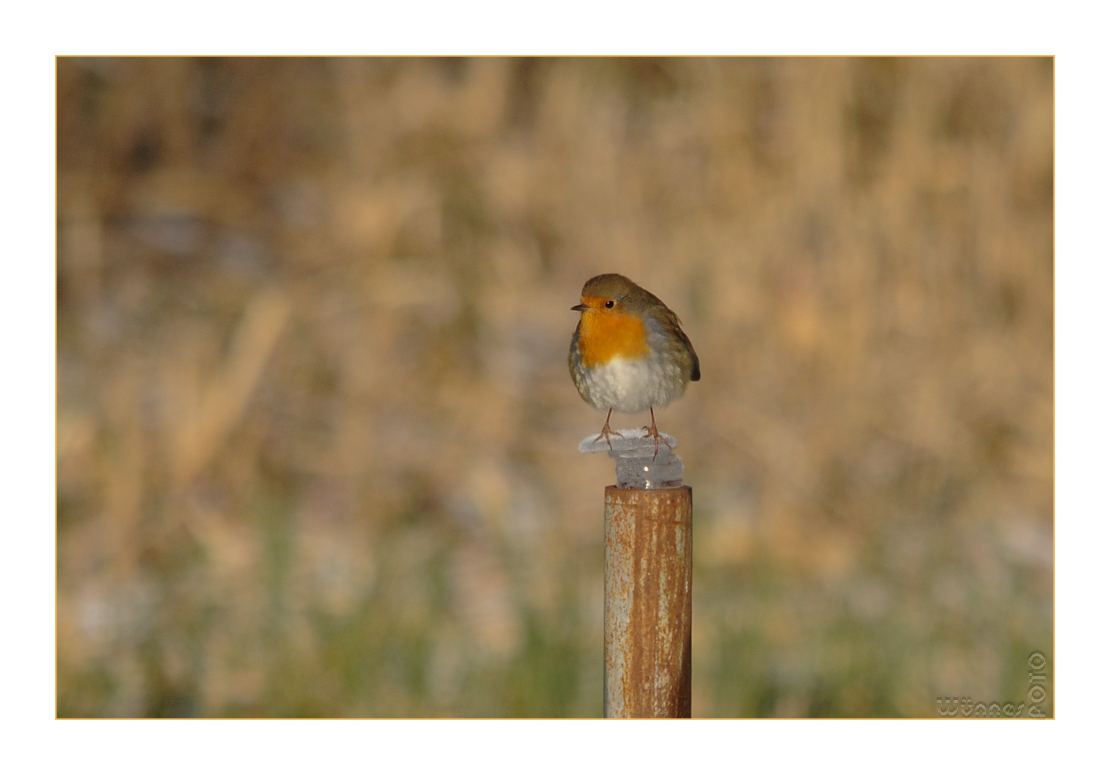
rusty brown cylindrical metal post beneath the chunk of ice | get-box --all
[605,485,694,718]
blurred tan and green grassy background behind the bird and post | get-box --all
[57,58,1053,717]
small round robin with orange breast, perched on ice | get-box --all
[568,274,702,454]
